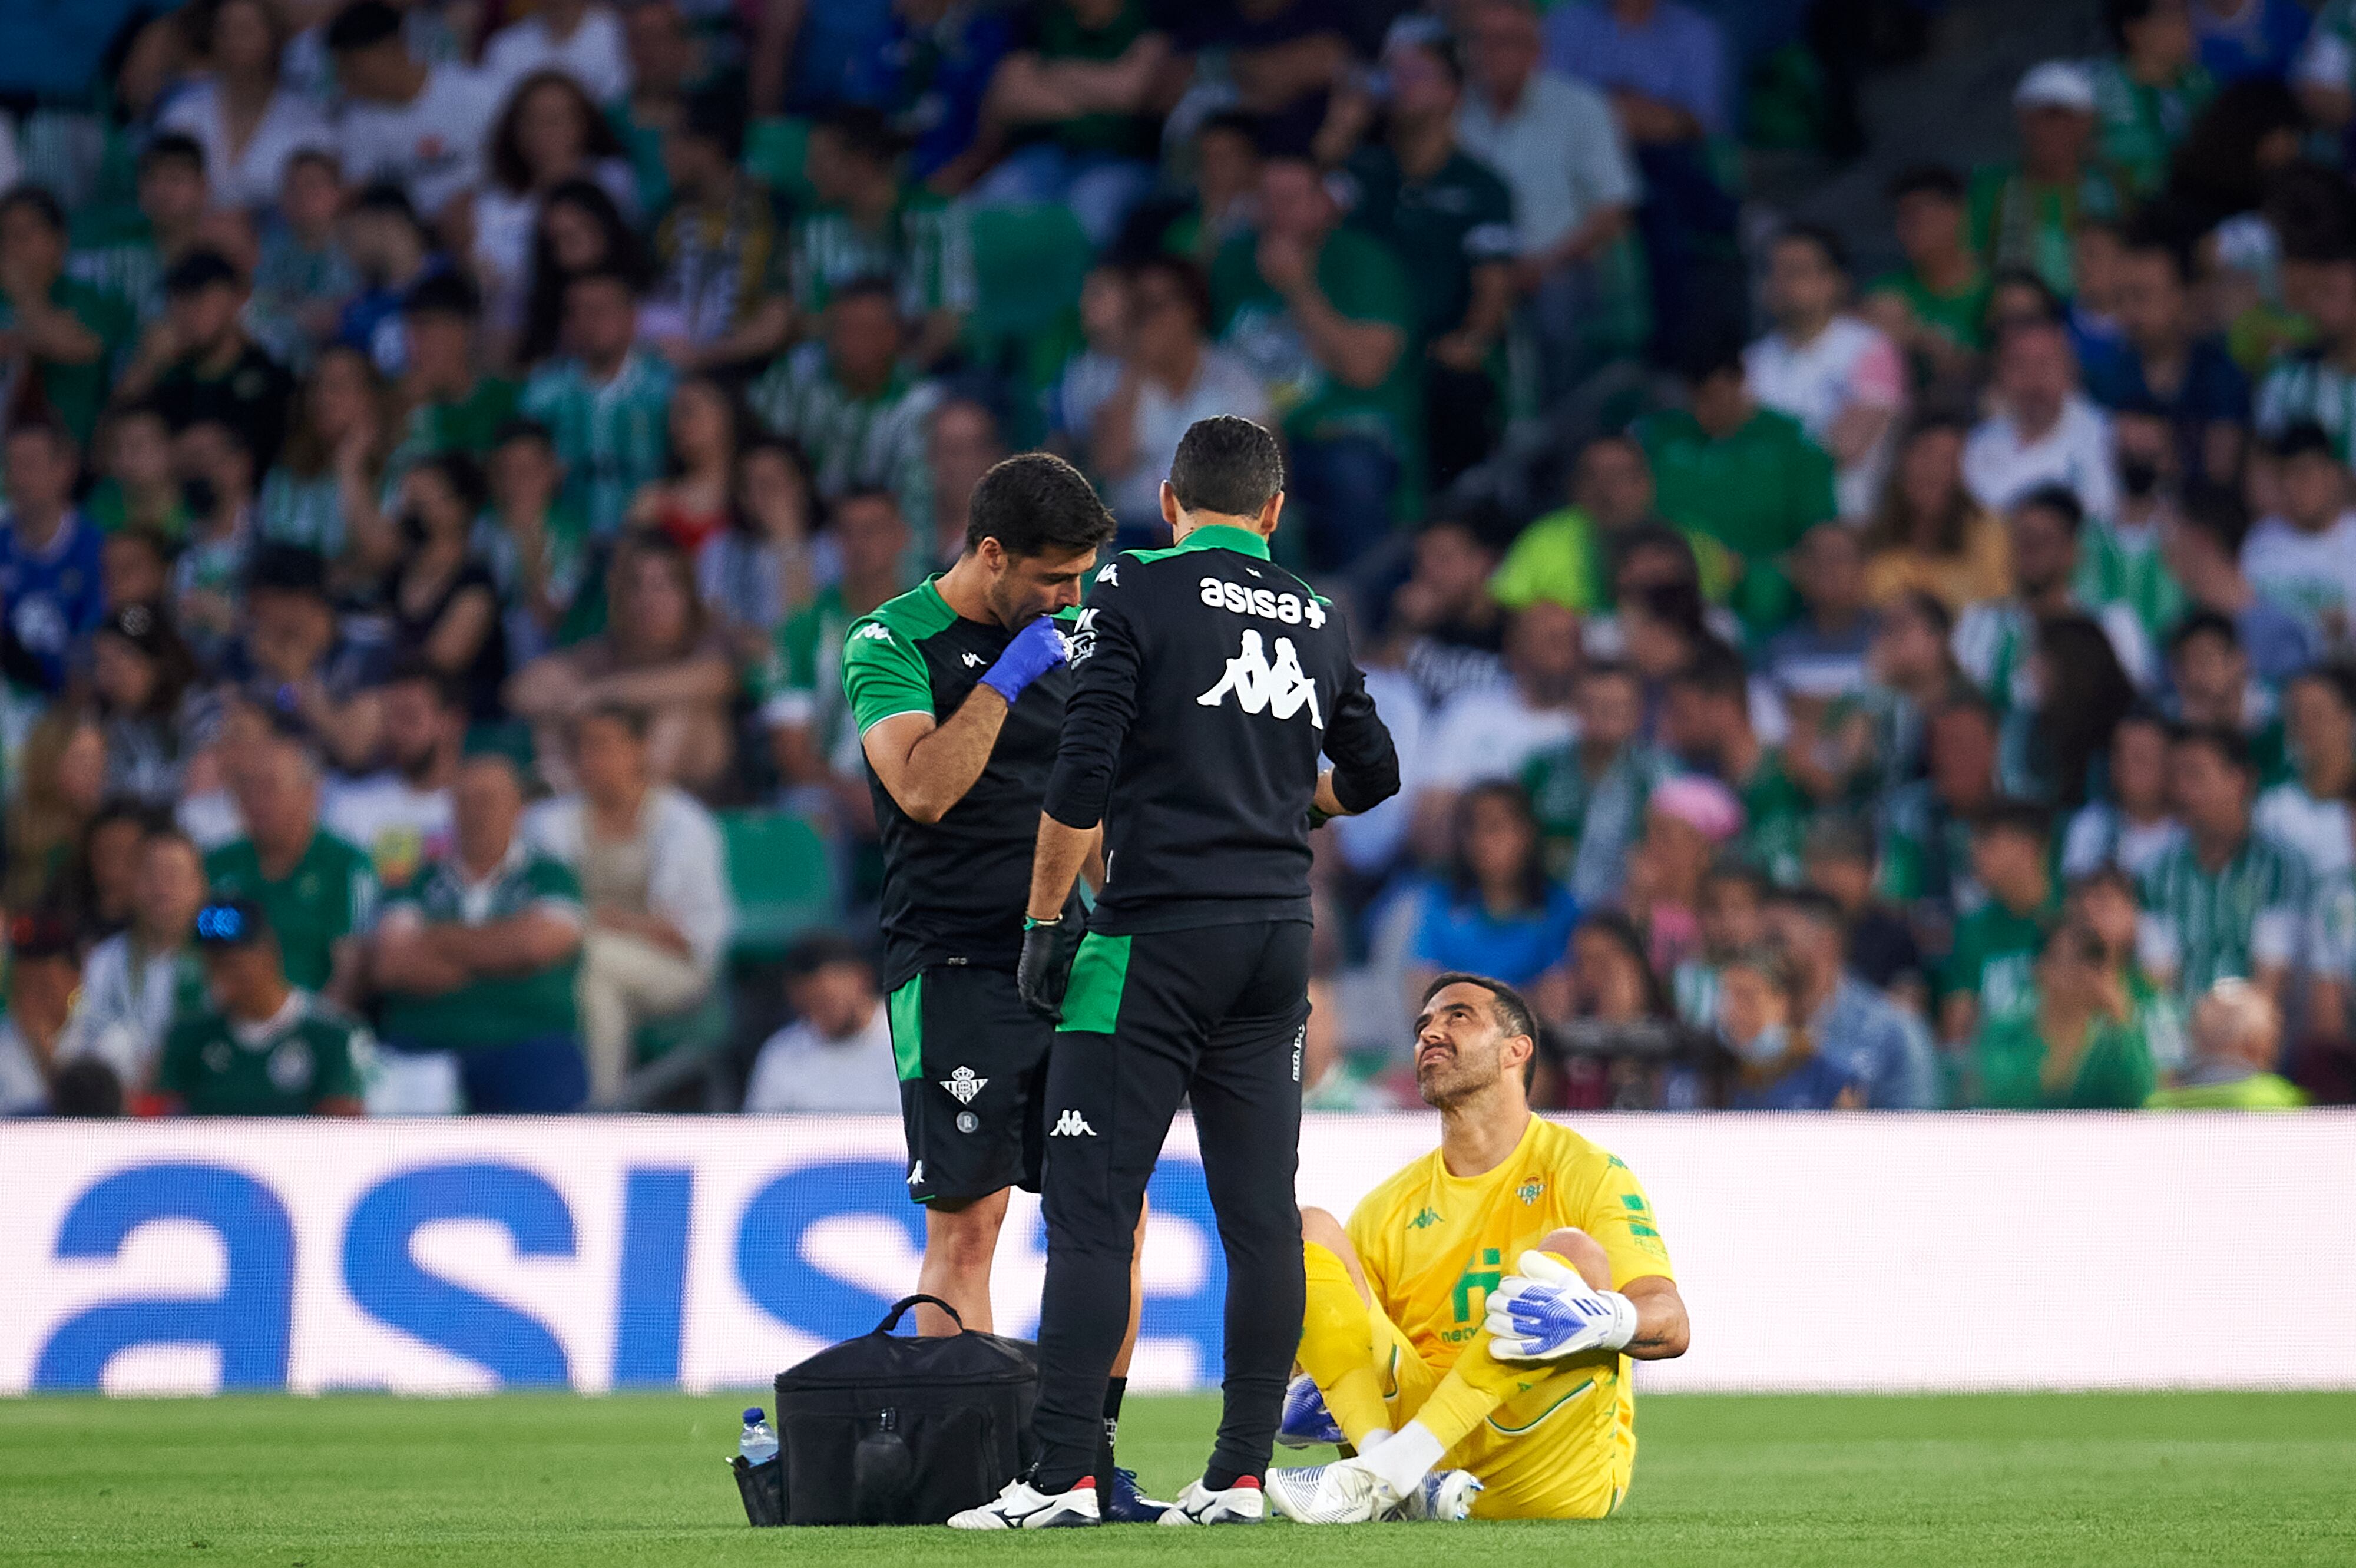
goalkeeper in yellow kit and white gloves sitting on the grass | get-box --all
[1268,975,1687,1523]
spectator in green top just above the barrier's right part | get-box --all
[1965,923,2158,1112]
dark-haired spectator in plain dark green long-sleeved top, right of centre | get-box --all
[1637,344,1840,633]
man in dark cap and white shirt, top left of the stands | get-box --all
[327,0,499,221]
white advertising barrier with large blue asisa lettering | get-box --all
[0,1112,2356,1394]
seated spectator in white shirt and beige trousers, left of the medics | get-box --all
[523,706,735,1104]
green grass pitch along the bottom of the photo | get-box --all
[0,1394,2356,1568]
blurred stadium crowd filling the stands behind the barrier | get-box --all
[0,0,2356,1114]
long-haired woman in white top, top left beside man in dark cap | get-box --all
[155,0,335,212]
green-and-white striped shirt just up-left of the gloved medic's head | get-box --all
[749,344,940,522]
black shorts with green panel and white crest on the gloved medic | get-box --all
[891,963,1055,1203]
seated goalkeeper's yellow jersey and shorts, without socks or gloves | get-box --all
[1350,1116,1675,1511]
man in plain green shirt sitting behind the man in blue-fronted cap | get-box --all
[205,737,377,1001]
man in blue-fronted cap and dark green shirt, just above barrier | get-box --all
[155,899,370,1116]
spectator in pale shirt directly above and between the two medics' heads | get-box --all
[1086,257,1275,532]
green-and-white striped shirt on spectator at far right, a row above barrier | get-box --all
[2137,831,2321,1001]
